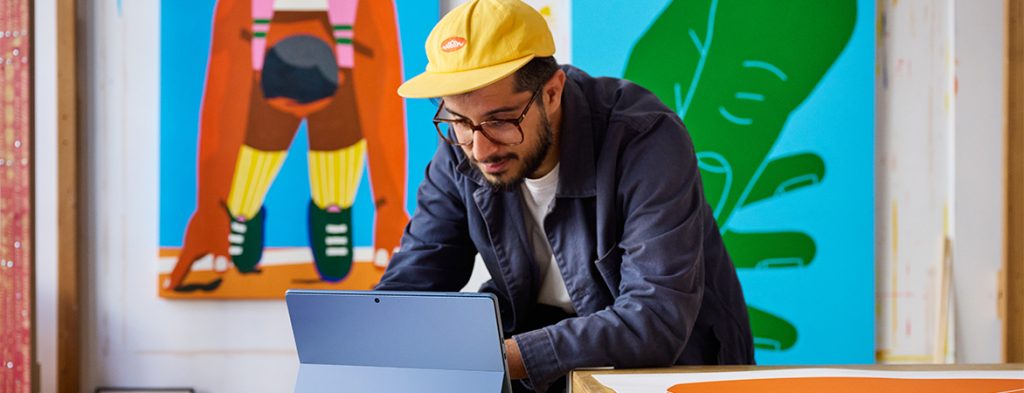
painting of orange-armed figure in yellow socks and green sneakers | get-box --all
[160,0,438,298]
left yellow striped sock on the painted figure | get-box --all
[227,144,288,218]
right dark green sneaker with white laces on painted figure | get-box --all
[309,201,352,282]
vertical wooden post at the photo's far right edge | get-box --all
[1004,0,1024,362]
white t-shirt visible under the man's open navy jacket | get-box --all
[521,165,575,313]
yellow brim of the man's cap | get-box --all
[398,54,535,98]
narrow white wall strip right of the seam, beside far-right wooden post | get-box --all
[952,0,1007,363]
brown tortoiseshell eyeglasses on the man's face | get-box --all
[434,85,544,146]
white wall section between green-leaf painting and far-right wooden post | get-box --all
[876,0,1006,362]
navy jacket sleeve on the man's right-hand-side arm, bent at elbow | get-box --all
[515,115,713,392]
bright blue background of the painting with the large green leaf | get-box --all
[572,0,876,364]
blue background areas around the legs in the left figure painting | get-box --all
[160,0,439,248]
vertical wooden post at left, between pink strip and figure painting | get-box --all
[56,0,82,393]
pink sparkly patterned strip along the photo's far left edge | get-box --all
[0,0,36,393]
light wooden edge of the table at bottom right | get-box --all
[569,363,1024,393]
